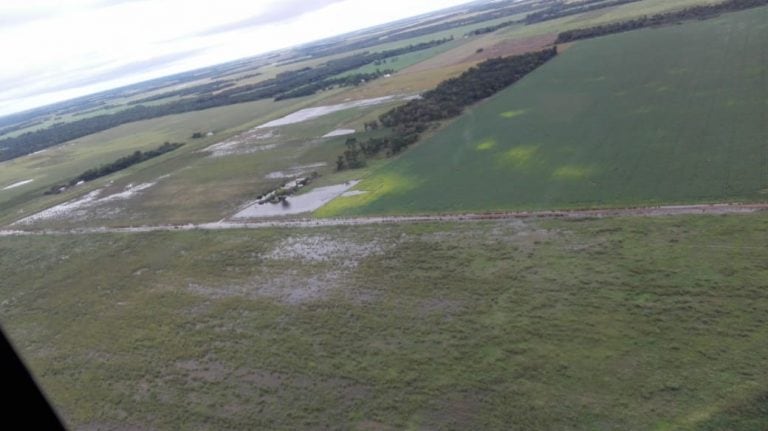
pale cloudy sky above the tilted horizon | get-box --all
[0,0,476,116]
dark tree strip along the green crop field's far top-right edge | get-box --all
[557,0,768,43]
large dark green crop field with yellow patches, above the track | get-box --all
[319,7,768,219]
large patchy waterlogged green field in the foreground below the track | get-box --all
[0,214,768,431]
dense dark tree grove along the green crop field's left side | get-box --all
[336,47,557,170]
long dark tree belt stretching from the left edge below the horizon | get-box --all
[0,38,451,161]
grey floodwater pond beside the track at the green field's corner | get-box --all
[232,181,359,219]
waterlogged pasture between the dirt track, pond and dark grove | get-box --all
[108,98,414,225]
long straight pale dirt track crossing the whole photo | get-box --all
[0,203,768,237]
